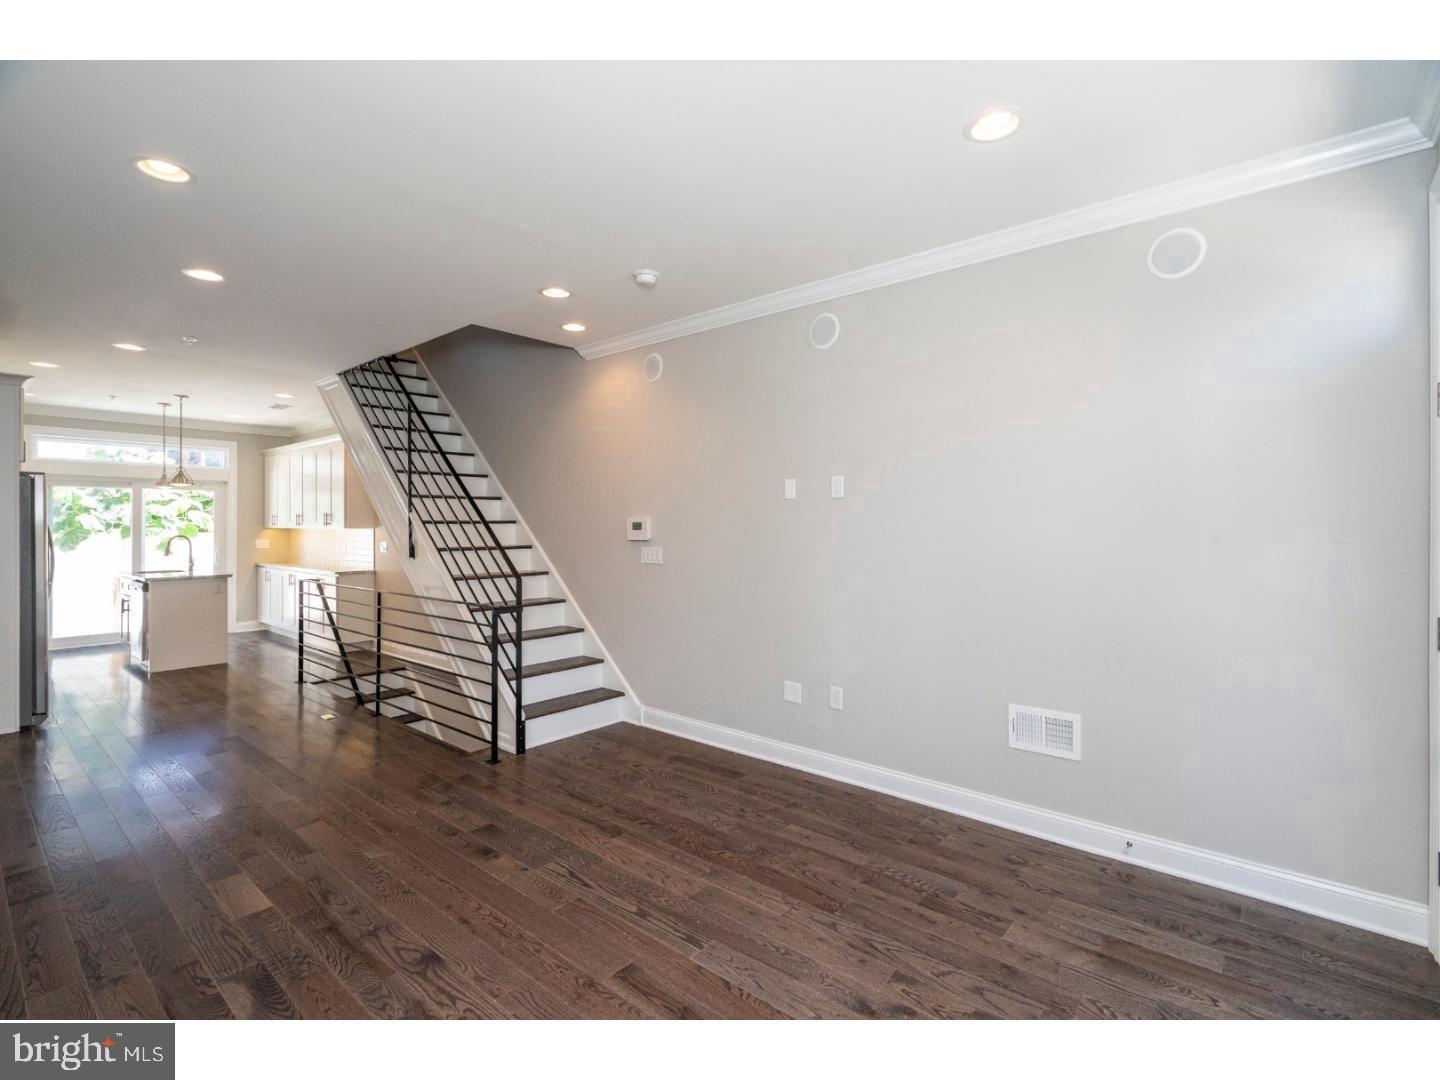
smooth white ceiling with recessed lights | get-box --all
[0,62,1426,428]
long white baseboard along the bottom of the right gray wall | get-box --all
[641,707,1430,945]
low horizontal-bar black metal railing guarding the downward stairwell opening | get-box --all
[297,577,501,762]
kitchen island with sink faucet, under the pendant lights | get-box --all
[120,570,230,674]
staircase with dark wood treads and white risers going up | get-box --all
[315,357,635,753]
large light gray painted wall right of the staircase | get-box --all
[420,153,1436,901]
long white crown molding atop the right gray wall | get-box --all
[576,120,1436,360]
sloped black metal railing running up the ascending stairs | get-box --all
[343,357,526,753]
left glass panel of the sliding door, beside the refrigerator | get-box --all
[49,481,134,647]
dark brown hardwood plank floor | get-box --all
[0,634,1440,1018]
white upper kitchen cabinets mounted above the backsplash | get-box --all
[265,435,377,528]
